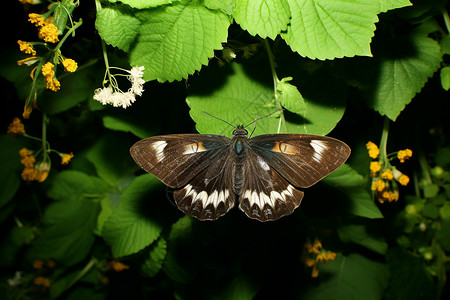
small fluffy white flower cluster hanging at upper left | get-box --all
[94,67,145,108]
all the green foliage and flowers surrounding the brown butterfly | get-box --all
[0,0,450,299]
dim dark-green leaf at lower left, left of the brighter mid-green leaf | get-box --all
[29,198,99,265]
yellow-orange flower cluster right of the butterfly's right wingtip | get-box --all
[366,142,412,203]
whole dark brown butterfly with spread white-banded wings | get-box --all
[130,118,350,222]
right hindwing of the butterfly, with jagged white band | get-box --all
[239,149,303,222]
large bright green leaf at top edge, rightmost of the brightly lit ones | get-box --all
[281,0,379,60]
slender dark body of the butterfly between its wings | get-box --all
[231,125,248,194]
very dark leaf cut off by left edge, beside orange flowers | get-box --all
[0,135,23,209]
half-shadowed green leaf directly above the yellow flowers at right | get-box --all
[355,30,442,121]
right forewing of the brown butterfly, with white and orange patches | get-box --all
[249,134,350,188]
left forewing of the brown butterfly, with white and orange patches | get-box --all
[130,134,230,188]
